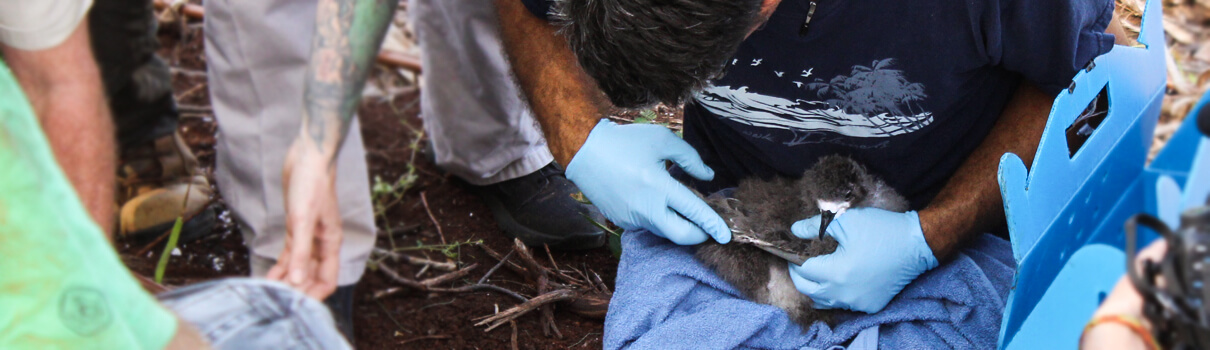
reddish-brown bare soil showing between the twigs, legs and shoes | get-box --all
[117,12,617,349]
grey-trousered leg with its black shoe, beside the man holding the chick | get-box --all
[408,0,606,249]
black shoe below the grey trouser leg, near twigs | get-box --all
[476,162,606,251]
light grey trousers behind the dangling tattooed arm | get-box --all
[204,0,376,286]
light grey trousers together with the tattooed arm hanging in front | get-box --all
[204,0,384,340]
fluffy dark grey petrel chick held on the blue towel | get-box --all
[696,155,908,329]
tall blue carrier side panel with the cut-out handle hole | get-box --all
[998,0,1166,348]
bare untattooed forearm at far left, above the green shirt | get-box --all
[0,22,117,235]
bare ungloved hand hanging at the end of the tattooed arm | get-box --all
[266,137,342,300]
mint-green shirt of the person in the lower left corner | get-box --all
[0,61,177,349]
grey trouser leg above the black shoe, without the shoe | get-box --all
[408,0,554,185]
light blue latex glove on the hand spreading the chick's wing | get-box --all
[565,120,731,245]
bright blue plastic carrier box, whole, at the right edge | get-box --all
[998,0,1210,349]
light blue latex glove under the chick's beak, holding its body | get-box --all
[790,208,937,314]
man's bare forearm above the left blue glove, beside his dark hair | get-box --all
[495,0,609,165]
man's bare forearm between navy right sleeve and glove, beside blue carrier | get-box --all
[920,82,1054,260]
